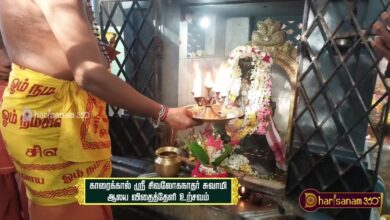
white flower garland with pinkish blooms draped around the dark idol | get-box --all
[227,45,272,140]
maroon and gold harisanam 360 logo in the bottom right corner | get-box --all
[299,189,383,212]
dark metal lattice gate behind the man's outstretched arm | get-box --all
[99,0,162,158]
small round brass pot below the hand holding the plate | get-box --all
[154,146,180,177]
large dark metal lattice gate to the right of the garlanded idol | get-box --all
[286,0,390,219]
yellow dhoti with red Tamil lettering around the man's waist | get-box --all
[0,65,111,206]
